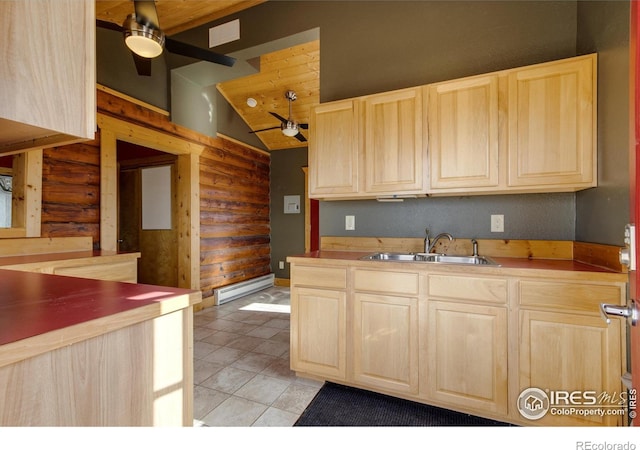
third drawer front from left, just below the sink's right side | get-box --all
[428,275,508,303]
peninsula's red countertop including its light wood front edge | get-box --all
[0,269,202,367]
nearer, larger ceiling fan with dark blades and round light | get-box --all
[96,0,236,76]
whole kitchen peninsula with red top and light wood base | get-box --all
[0,270,201,426]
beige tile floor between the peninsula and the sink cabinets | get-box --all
[189,286,322,427]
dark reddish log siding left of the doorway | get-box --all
[41,140,100,249]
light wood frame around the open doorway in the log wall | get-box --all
[97,113,204,290]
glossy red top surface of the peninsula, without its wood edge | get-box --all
[0,269,201,345]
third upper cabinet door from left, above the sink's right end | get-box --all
[427,75,499,191]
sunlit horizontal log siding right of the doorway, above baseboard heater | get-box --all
[200,139,271,298]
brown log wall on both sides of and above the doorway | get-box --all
[37,89,271,304]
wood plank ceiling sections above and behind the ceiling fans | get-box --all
[96,0,320,150]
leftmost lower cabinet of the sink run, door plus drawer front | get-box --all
[290,266,347,380]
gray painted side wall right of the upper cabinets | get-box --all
[576,1,629,245]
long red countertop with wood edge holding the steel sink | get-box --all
[287,250,628,282]
